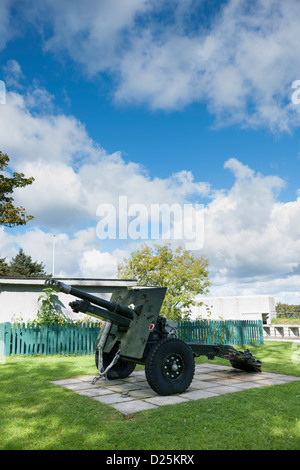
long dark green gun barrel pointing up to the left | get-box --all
[45,278,136,320]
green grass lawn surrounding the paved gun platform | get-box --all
[0,342,300,450]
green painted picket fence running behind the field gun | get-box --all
[0,320,263,356]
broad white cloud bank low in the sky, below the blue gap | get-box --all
[0,80,300,298]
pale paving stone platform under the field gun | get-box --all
[51,364,300,415]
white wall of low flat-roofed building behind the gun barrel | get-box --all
[0,277,136,323]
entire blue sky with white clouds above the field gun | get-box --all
[0,0,300,303]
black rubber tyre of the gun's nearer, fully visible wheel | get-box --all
[145,337,195,396]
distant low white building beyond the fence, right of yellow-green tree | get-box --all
[192,295,276,324]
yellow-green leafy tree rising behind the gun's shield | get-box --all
[117,244,210,321]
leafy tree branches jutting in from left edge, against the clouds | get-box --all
[0,152,34,227]
